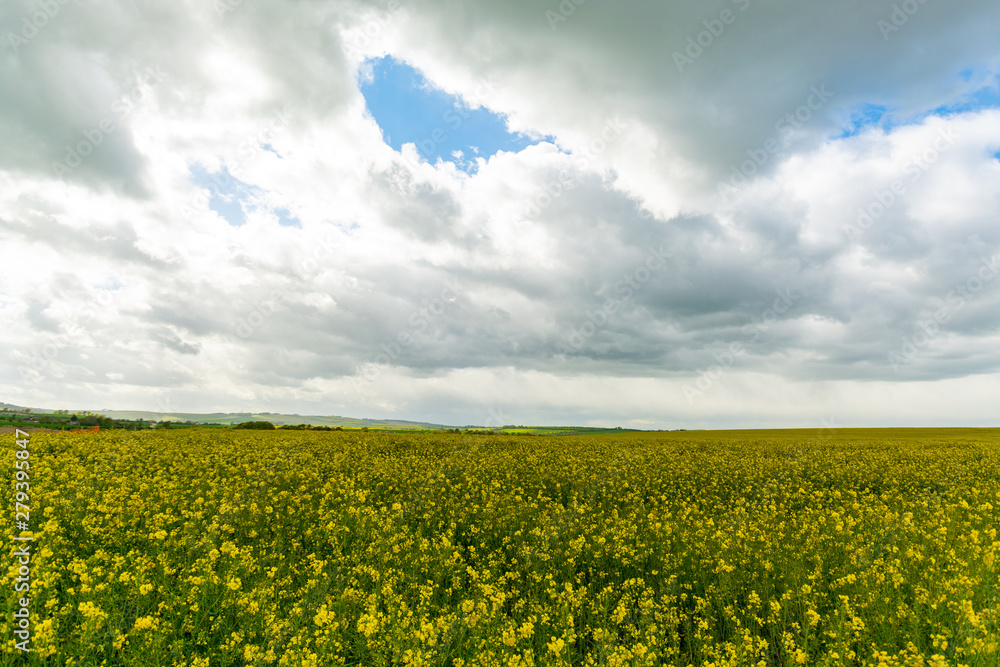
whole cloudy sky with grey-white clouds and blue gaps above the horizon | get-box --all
[0,0,1000,429]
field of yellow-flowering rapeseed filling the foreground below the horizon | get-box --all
[0,428,1000,667]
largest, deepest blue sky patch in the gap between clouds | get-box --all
[359,56,541,173]
